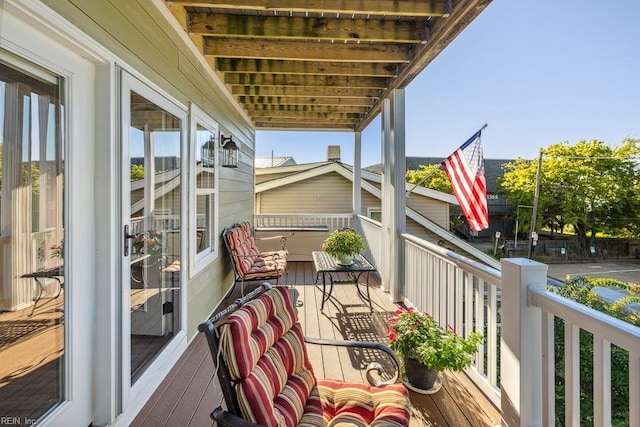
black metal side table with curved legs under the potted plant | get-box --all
[311,251,376,311]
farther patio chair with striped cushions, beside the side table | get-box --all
[222,222,289,295]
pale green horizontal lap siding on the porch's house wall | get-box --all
[43,0,255,336]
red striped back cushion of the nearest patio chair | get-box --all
[218,288,315,427]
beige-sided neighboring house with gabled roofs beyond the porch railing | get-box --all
[255,150,499,267]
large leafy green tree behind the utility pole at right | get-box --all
[499,139,640,250]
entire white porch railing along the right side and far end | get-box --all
[256,214,640,426]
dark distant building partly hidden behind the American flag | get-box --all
[364,157,517,238]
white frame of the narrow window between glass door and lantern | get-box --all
[189,103,220,278]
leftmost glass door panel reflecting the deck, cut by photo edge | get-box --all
[0,52,68,425]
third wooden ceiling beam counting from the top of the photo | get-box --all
[204,37,410,63]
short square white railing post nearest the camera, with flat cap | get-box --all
[500,258,547,427]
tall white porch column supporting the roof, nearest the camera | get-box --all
[381,89,407,300]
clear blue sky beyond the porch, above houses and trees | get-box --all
[256,0,640,166]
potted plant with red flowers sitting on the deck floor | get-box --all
[389,308,483,390]
